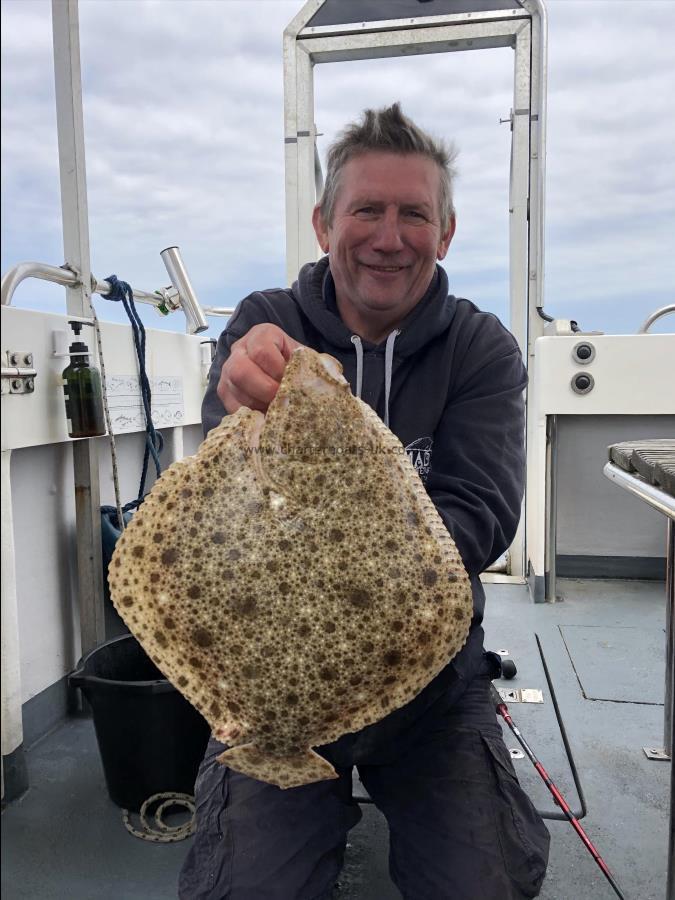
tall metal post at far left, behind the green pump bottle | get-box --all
[52,0,105,653]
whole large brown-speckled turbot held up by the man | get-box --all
[109,348,472,788]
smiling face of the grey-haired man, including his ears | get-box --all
[313,152,455,339]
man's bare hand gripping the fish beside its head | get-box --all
[217,323,302,413]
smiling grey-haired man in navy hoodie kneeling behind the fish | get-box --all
[180,104,549,900]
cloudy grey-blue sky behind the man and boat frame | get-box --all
[2,0,675,334]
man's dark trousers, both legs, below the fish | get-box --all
[179,659,549,900]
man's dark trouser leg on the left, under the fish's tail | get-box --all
[179,742,361,900]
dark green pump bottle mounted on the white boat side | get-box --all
[62,322,105,438]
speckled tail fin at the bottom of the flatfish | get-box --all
[218,743,338,788]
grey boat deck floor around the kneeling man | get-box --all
[2,580,670,900]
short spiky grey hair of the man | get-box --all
[320,103,457,231]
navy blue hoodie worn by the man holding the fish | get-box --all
[202,256,527,744]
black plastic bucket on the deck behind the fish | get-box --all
[69,634,210,812]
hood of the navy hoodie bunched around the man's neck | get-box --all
[292,256,457,357]
